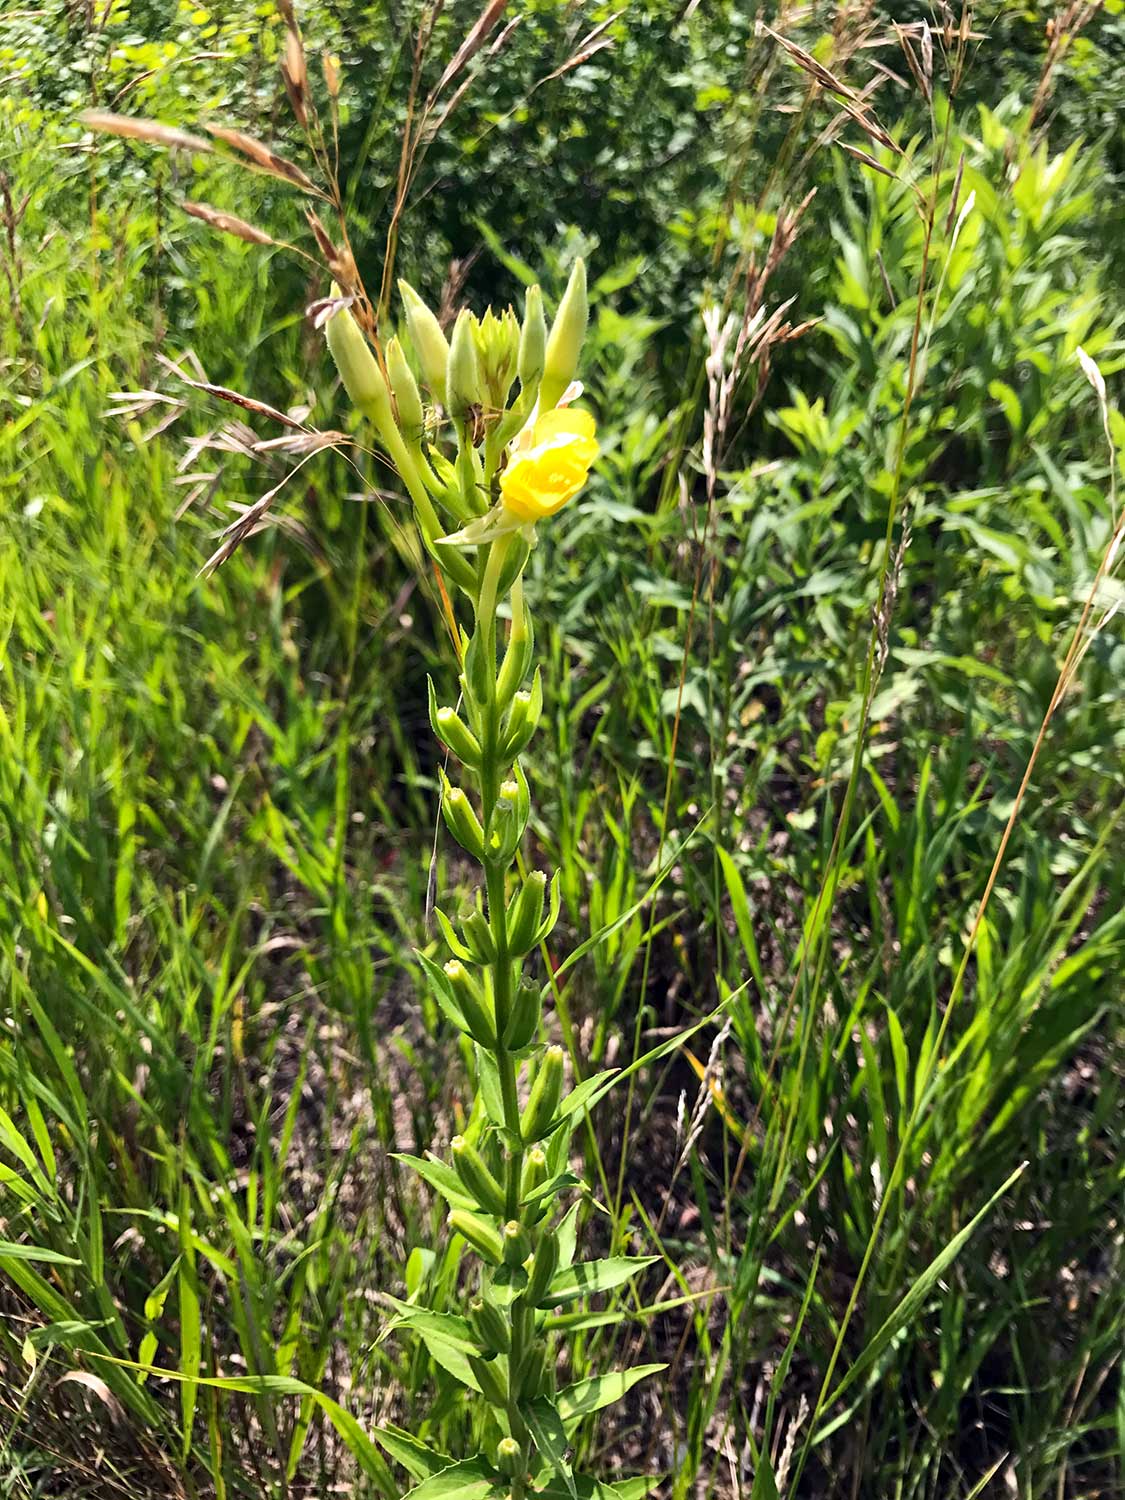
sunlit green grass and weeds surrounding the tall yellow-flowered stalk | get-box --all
[0,8,1125,1500]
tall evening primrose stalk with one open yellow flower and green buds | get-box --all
[326,261,662,1500]
